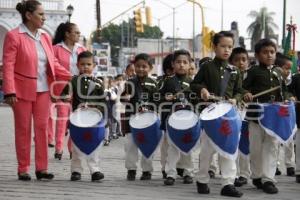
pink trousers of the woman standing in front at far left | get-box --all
[13,92,50,173]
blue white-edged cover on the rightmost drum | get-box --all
[259,102,297,144]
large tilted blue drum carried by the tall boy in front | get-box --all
[200,102,242,160]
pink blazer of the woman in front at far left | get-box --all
[3,27,71,101]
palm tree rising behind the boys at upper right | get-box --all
[247,7,278,50]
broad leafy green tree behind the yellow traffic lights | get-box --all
[91,19,163,66]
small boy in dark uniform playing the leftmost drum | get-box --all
[62,51,105,181]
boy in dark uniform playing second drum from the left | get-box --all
[121,53,157,181]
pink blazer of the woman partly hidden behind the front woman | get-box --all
[53,44,86,96]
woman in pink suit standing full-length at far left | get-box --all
[3,0,70,181]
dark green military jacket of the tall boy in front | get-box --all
[191,58,246,101]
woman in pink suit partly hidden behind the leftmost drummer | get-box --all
[48,22,86,160]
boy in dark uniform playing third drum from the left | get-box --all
[159,50,196,185]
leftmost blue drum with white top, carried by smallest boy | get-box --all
[70,108,105,155]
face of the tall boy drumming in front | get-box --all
[214,37,233,60]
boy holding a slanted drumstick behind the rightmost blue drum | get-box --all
[243,39,288,194]
